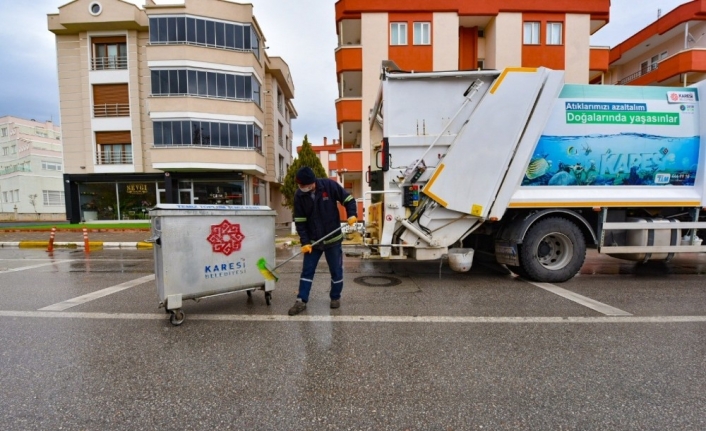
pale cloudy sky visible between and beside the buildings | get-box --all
[0,0,689,145]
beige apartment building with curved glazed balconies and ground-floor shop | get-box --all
[48,0,297,224]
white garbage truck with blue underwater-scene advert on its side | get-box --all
[365,66,706,282]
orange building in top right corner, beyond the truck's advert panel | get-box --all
[603,0,706,87]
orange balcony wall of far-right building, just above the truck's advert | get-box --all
[617,49,706,85]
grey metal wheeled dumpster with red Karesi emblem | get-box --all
[148,204,276,325]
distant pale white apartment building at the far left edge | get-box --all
[0,116,66,221]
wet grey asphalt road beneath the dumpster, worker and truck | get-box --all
[0,249,706,430]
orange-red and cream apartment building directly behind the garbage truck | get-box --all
[335,0,610,207]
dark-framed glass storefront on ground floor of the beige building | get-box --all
[64,172,267,223]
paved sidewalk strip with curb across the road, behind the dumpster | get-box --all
[0,228,299,249]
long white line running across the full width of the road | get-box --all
[0,311,706,324]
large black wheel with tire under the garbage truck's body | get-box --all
[518,217,586,283]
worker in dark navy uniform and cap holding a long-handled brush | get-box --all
[289,166,358,316]
